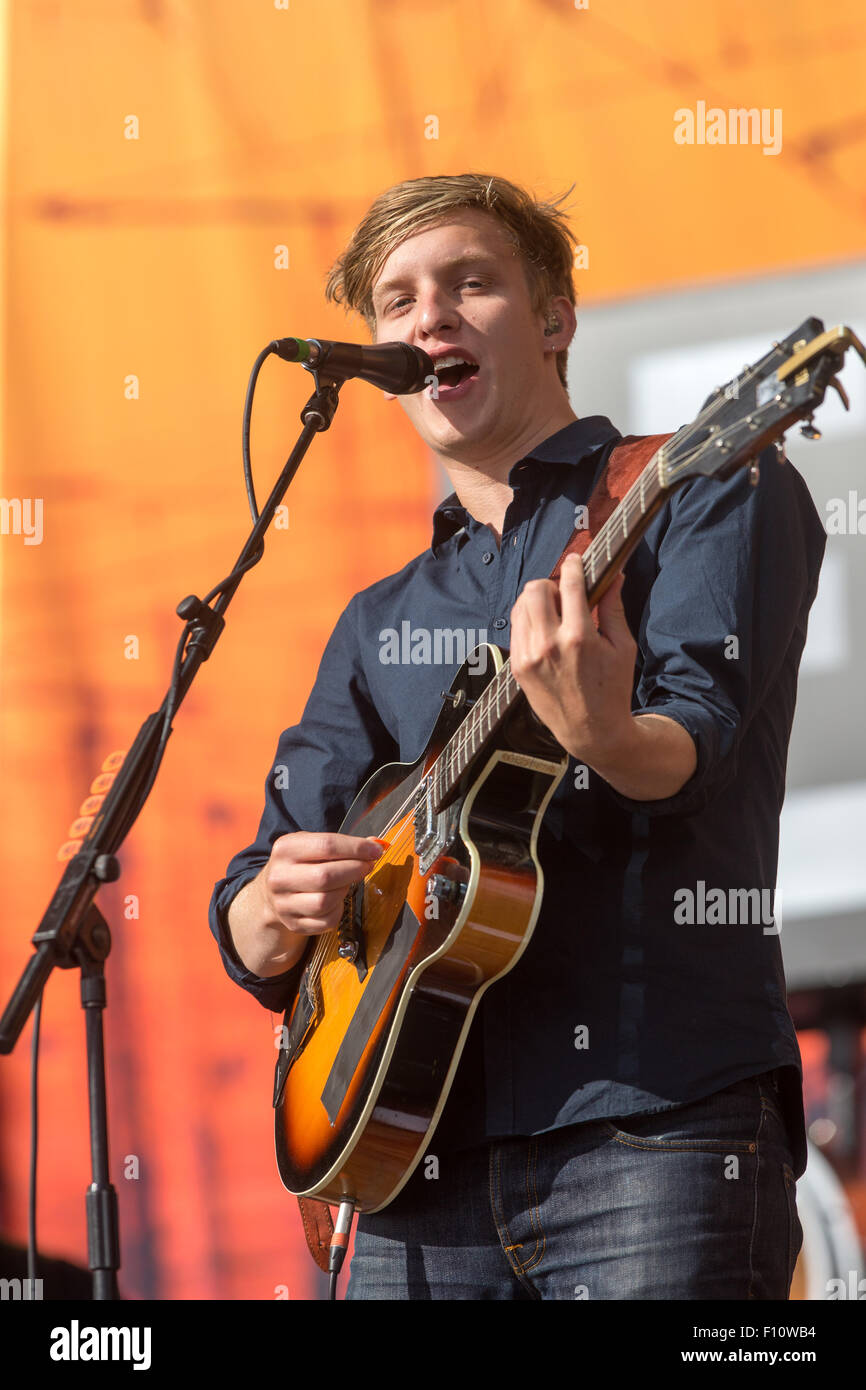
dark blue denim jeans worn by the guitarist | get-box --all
[346,1073,802,1300]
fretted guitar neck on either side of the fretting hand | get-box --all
[428,441,673,810]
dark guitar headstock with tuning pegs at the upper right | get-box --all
[659,318,866,488]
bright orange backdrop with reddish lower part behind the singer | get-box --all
[0,0,866,1298]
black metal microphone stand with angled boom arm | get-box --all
[0,366,346,1300]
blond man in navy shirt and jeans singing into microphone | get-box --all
[210,174,824,1300]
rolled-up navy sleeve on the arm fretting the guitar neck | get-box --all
[612,448,826,816]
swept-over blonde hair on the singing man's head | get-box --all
[325,174,578,392]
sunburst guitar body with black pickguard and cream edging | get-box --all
[275,646,567,1212]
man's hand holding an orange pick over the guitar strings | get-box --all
[228,830,382,979]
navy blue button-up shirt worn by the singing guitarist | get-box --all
[210,416,826,1175]
